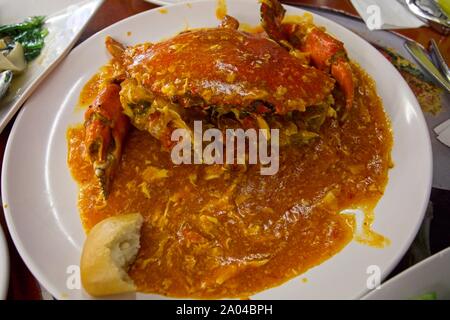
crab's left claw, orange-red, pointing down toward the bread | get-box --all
[84,83,129,199]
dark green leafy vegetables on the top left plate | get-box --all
[0,16,48,61]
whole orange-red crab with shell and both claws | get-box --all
[85,0,354,199]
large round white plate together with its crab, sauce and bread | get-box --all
[2,1,432,299]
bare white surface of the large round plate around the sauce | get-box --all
[2,0,432,299]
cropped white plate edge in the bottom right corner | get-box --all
[363,248,450,300]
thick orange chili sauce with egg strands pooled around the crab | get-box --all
[67,61,392,298]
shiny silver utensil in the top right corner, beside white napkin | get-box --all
[406,0,450,35]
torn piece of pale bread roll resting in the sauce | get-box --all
[80,213,143,297]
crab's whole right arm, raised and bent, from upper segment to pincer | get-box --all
[261,0,355,110]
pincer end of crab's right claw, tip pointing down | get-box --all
[301,27,355,109]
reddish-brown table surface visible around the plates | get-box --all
[0,0,450,300]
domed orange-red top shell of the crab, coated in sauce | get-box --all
[121,28,335,114]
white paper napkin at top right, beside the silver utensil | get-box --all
[351,0,426,30]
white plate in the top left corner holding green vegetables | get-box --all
[0,0,103,132]
